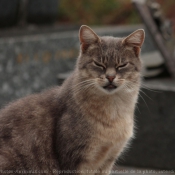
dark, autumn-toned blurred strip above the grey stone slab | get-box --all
[0,0,175,28]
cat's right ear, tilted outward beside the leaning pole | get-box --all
[122,29,145,56]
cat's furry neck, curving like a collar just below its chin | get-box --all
[63,74,139,126]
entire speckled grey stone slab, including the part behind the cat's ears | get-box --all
[0,25,155,107]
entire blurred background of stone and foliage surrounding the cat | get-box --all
[0,0,175,174]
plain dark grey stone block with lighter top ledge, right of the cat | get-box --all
[119,79,175,170]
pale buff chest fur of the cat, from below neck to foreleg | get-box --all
[77,90,135,174]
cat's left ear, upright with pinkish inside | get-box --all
[79,25,100,52]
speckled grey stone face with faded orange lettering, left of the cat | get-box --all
[0,34,78,107]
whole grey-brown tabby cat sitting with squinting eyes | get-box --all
[0,25,145,175]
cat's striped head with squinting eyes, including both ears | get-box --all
[77,25,145,94]
